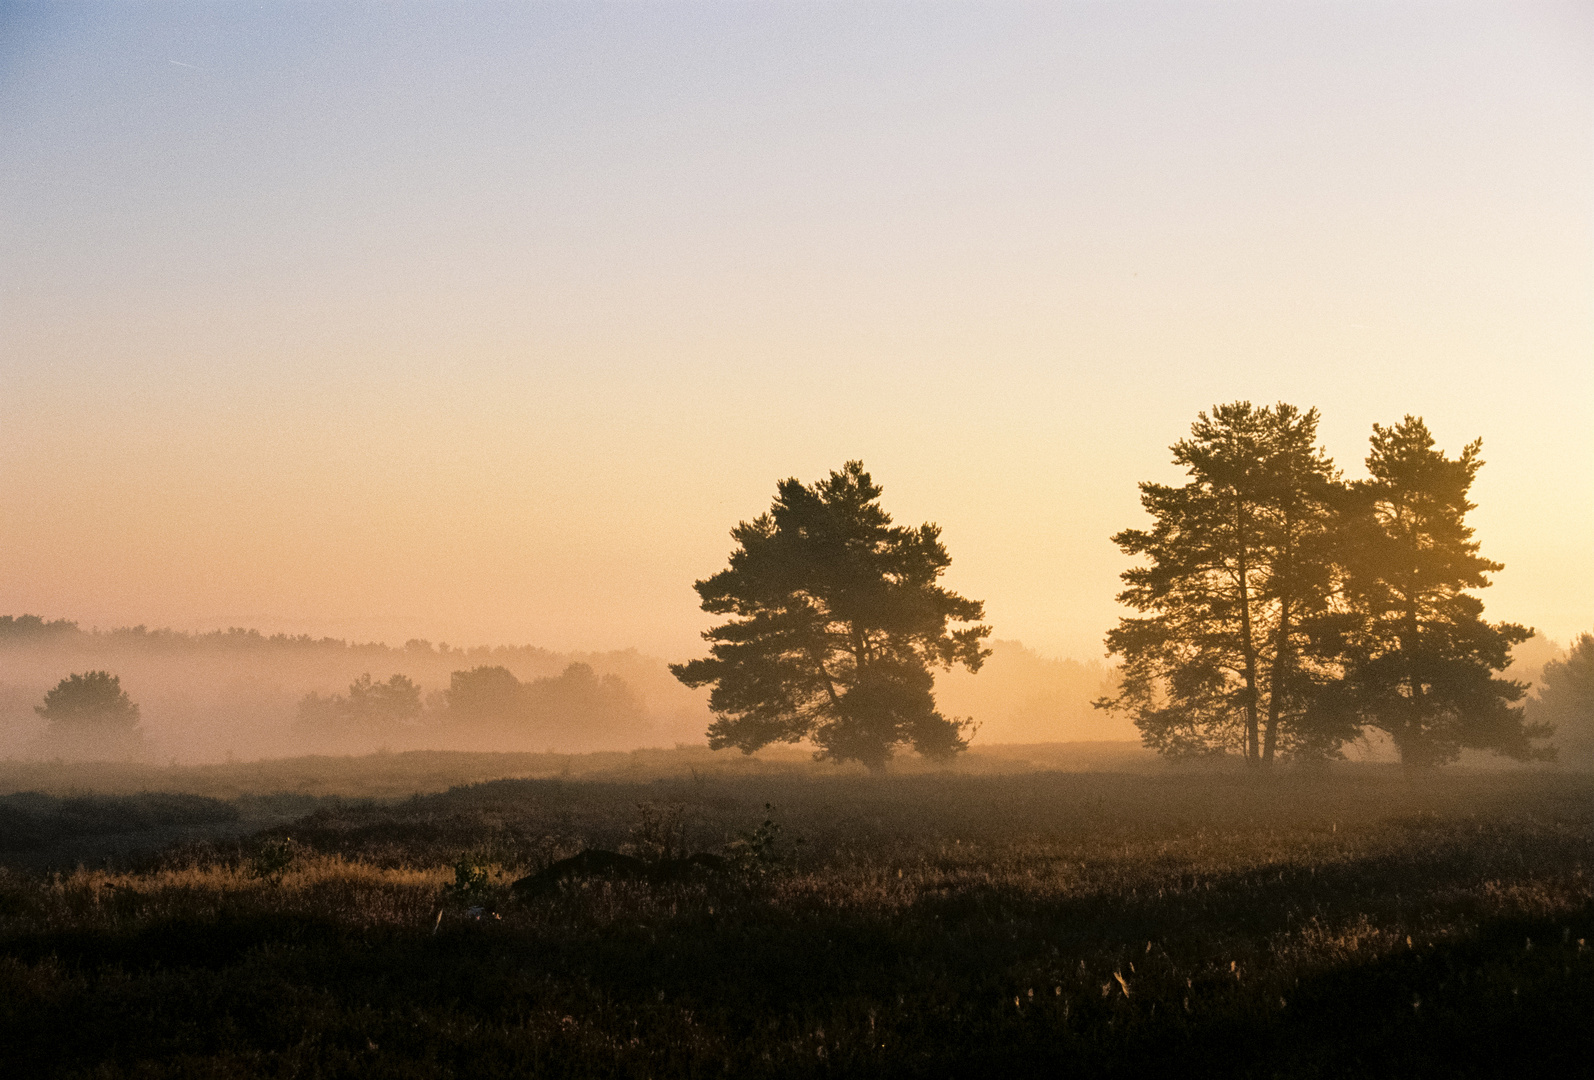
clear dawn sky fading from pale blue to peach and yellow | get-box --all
[0,0,1594,659]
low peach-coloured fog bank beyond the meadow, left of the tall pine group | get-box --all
[0,616,1137,765]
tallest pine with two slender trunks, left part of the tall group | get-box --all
[1098,401,1353,765]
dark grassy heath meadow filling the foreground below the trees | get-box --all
[0,766,1594,1077]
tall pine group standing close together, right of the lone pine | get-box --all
[1100,401,1553,765]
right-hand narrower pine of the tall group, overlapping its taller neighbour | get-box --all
[1328,416,1553,766]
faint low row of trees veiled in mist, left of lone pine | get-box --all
[298,663,646,736]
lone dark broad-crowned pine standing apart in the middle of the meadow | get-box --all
[671,462,990,771]
